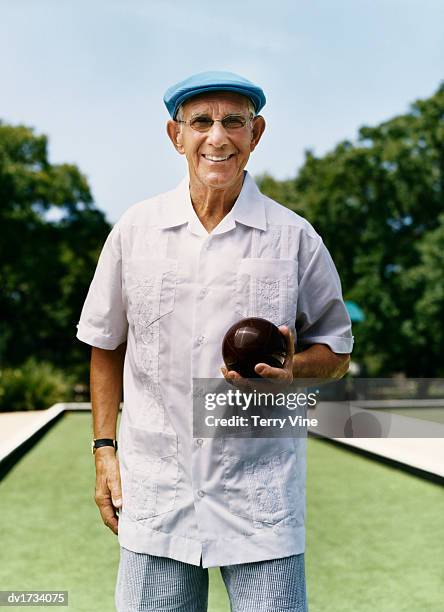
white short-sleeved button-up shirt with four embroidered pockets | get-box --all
[77,172,353,567]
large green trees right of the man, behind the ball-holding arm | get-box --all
[259,84,444,377]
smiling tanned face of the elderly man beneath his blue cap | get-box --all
[167,92,265,189]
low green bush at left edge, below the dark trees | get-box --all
[0,357,74,412]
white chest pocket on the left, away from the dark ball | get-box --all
[124,257,177,342]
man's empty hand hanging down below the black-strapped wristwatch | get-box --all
[94,446,122,535]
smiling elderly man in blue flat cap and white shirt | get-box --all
[77,72,353,612]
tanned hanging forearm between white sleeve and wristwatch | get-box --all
[90,343,126,439]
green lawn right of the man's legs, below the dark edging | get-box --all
[306,440,444,612]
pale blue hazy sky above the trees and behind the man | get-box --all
[0,0,444,223]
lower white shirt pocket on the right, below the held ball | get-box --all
[223,438,298,528]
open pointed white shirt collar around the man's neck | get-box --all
[159,171,267,234]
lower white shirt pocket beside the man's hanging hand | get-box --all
[123,427,179,520]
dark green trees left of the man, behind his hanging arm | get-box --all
[0,122,110,381]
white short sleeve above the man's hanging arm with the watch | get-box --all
[77,226,128,350]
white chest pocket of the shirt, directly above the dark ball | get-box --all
[235,257,298,327]
